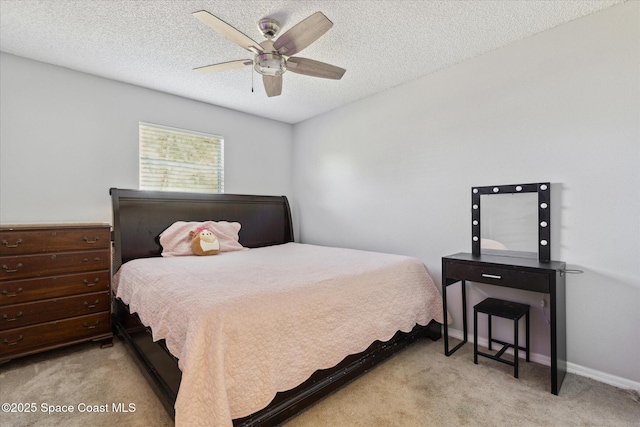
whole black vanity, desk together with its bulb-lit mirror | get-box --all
[442,182,567,395]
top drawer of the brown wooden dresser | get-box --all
[0,227,111,256]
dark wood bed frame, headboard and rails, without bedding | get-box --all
[110,188,441,427]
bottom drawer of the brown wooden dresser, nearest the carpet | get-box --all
[0,312,111,360]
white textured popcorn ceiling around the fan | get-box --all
[0,0,624,123]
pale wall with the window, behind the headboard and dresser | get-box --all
[0,53,292,224]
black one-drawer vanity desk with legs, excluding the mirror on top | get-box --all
[442,253,567,395]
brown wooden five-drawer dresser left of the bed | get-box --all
[0,224,113,363]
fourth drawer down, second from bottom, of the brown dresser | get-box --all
[0,292,111,331]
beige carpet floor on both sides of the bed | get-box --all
[0,340,640,427]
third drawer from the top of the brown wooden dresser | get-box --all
[0,270,110,307]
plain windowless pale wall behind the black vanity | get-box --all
[293,2,640,387]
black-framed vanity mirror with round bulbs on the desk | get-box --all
[471,182,551,261]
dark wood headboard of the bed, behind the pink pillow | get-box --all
[109,188,293,272]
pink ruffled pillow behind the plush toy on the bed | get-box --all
[160,221,246,257]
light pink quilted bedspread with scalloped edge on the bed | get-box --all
[114,243,442,426]
